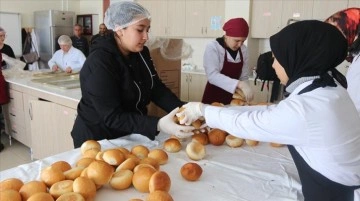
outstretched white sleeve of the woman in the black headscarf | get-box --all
[204,100,307,145]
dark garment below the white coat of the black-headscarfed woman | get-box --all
[288,145,360,201]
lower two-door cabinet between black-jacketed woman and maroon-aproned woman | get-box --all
[180,72,207,102]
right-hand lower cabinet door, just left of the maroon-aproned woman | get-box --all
[188,73,207,101]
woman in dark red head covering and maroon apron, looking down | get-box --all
[202,18,254,104]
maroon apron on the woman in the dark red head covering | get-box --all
[202,49,244,105]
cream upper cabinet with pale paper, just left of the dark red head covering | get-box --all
[185,0,225,37]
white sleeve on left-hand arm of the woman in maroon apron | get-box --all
[204,41,239,93]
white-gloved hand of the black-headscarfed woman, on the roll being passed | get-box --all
[176,102,203,125]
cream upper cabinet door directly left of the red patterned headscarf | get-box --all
[313,0,348,21]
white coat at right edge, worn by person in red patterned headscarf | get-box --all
[346,53,360,114]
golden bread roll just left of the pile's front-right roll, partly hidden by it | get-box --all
[132,167,156,193]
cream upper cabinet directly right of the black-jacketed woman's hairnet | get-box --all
[137,0,185,37]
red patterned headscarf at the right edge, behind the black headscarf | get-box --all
[325,8,360,46]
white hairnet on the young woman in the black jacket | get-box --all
[104,1,151,31]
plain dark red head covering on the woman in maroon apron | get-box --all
[223,18,249,38]
